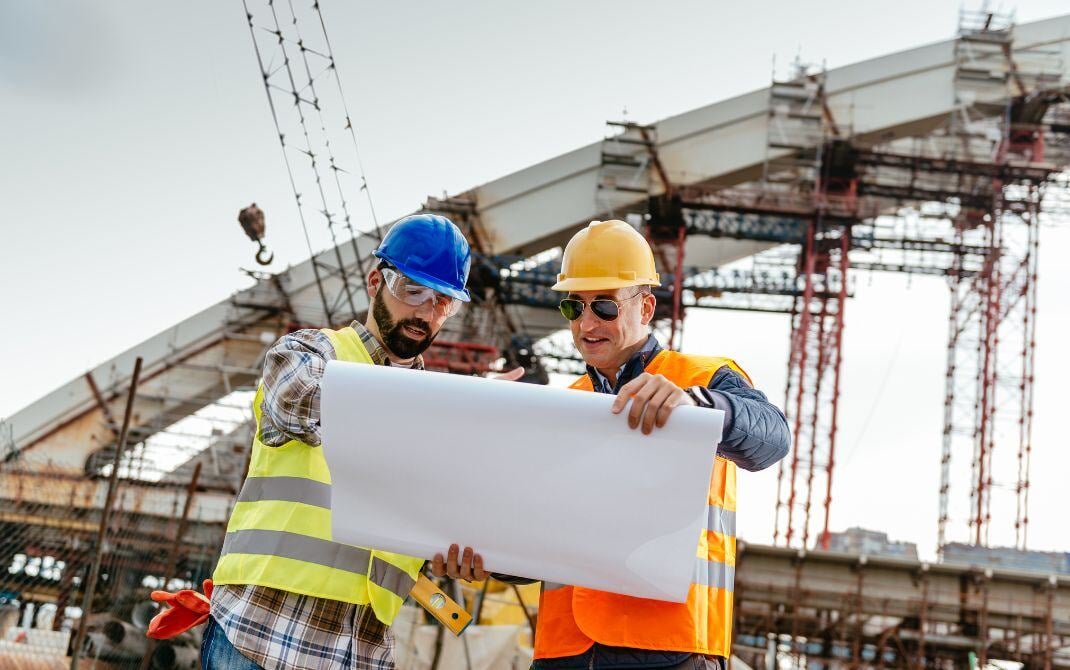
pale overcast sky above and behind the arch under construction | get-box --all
[0,0,1070,554]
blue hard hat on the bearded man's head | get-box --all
[372,214,472,303]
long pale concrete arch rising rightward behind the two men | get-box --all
[0,15,1070,514]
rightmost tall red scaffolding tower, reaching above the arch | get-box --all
[937,13,1066,551]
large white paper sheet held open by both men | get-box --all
[321,361,724,603]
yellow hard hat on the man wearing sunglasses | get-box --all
[552,220,661,291]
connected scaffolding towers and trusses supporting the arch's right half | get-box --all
[483,27,1068,548]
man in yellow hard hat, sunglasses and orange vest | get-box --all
[533,220,791,670]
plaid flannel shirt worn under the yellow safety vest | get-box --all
[212,322,424,670]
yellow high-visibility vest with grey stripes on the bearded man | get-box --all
[212,328,424,625]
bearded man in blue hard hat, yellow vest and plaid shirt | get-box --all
[201,214,488,670]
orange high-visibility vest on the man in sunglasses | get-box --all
[535,351,750,658]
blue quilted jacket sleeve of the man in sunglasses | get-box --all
[688,366,792,472]
